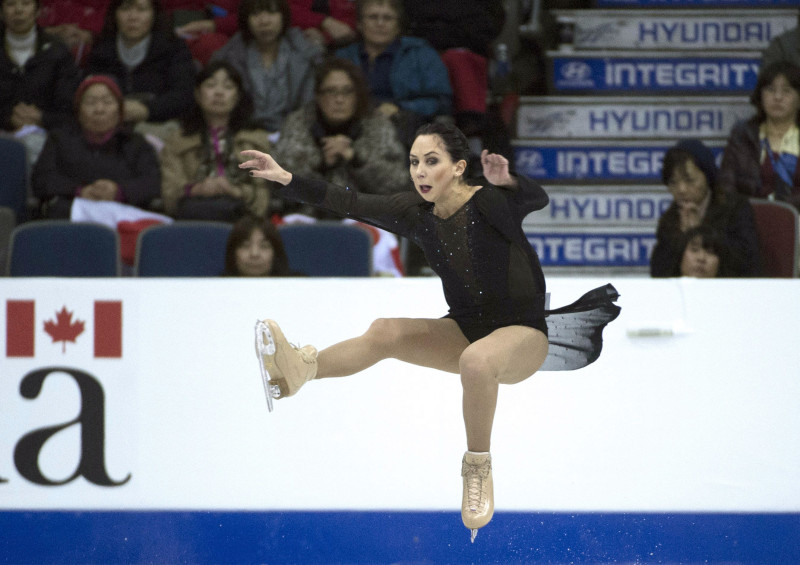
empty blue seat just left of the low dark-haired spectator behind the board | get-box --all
[133,220,232,277]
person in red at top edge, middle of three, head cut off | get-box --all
[161,0,239,67]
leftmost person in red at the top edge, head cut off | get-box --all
[37,0,109,66]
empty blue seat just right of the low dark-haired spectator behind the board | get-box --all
[278,221,372,277]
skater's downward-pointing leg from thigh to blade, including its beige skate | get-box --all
[459,326,548,541]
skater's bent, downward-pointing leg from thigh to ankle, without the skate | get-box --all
[459,326,547,452]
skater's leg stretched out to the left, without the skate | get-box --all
[317,318,469,379]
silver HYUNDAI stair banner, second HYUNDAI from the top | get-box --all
[516,95,754,140]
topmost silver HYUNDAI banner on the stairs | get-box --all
[553,9,798,50]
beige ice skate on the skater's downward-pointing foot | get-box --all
[461,451,494,542]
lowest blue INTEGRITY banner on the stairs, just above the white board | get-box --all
[525,229,656,267]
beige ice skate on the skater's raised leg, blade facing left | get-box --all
[255,320,317,412]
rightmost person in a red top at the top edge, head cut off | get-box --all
[289,0,356,51]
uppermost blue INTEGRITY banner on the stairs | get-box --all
[547,51,761,94]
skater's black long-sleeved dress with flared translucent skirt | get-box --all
[281,175,620,371]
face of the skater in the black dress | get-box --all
[409,135,467,203]
